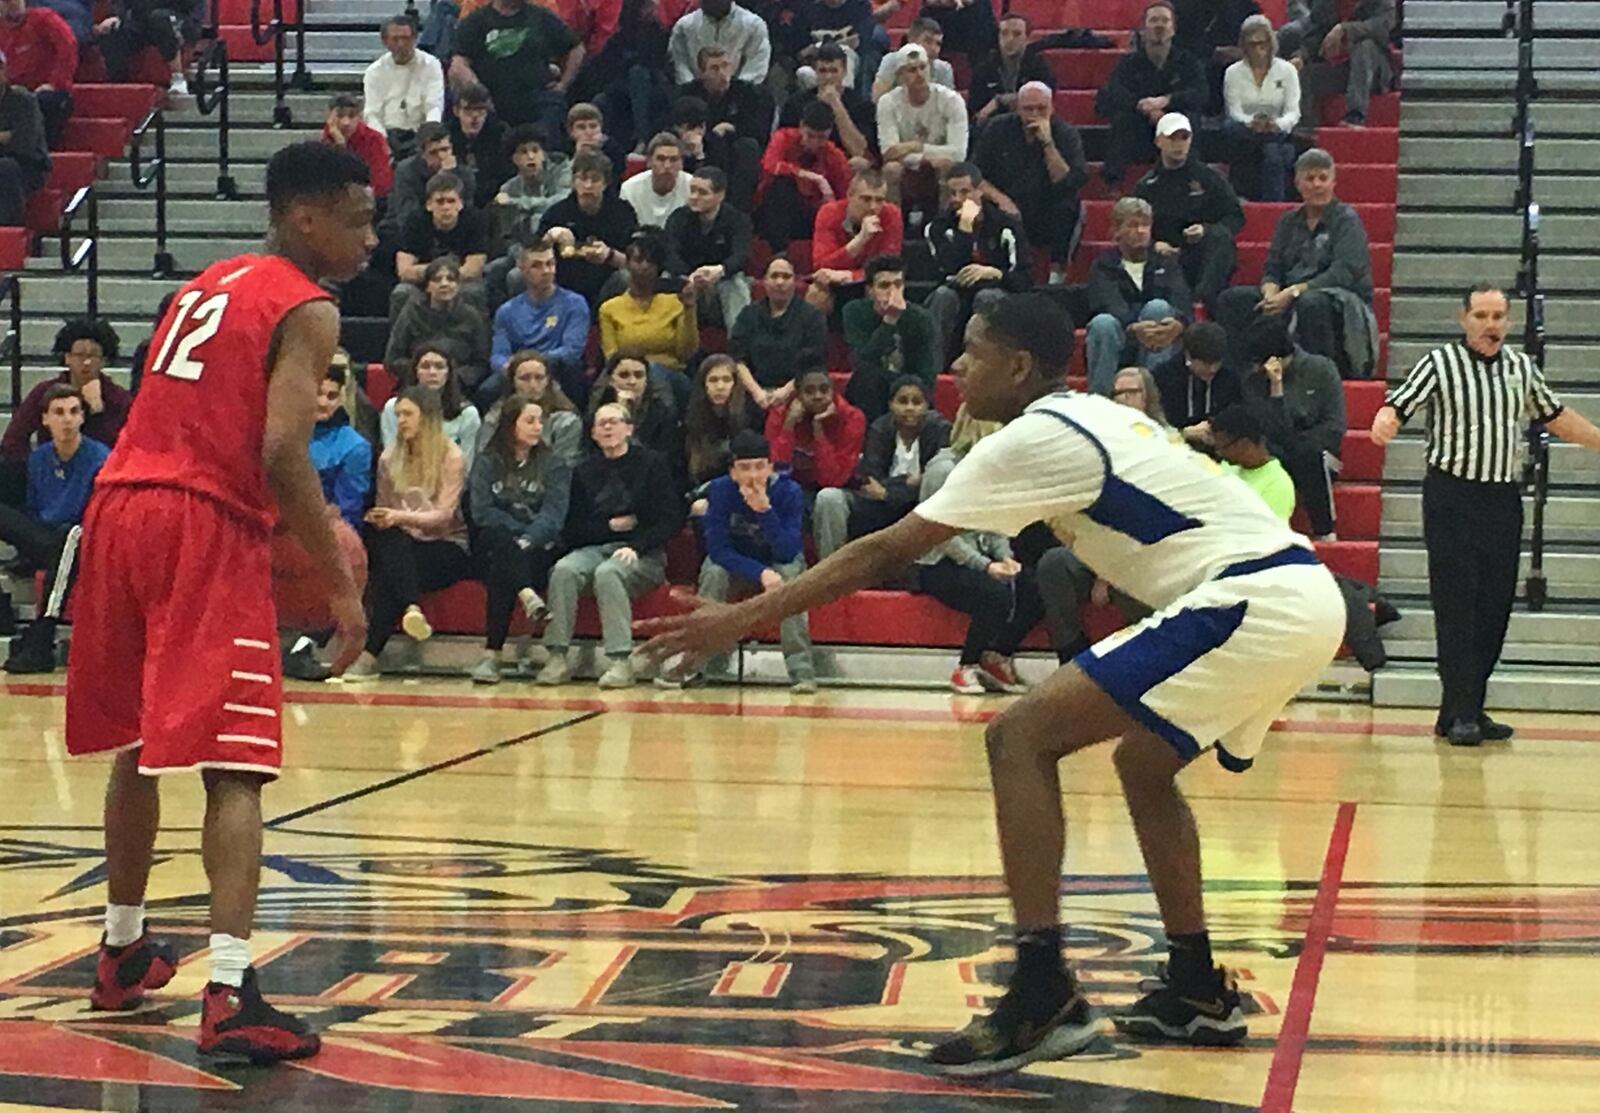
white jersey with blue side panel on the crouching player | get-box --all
[917,392,1315,609]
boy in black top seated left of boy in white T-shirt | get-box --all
[537,150,638,309]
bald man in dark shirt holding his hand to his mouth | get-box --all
[974,82,1090,283]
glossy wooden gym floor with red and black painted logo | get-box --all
[0,681,1600,1113]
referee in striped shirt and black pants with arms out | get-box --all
[1373,285,1600,745]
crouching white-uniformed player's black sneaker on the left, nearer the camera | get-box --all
[928,975,1099,1078]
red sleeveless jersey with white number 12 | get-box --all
[98,256,328,533]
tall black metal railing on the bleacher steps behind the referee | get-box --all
[1502,0,1550,611]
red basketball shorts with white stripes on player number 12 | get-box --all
[67,488,283,777]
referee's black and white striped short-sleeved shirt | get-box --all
[1386,342,1563,483]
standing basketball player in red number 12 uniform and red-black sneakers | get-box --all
[67,142,376,1062]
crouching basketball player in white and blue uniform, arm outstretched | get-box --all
[642,294,1344,1076]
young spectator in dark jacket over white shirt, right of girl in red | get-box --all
[811,374,950,558]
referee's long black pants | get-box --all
[1422,469,1522,729]
